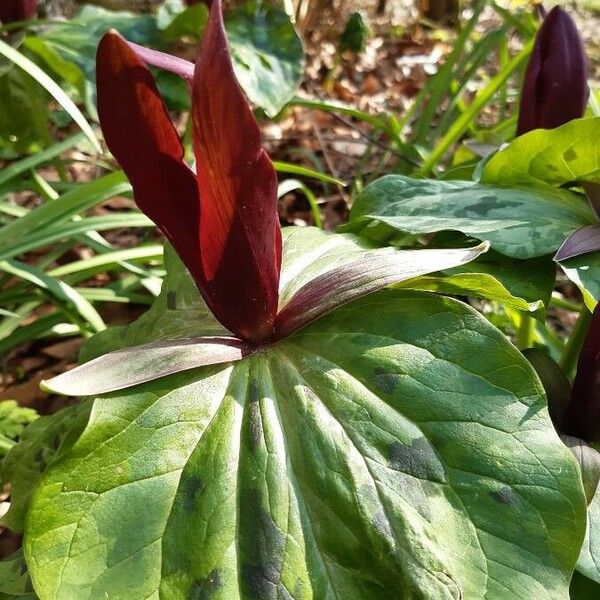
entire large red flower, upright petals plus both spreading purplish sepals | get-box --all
[42,0,489,396]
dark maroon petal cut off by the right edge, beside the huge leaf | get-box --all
[564,304,600,442]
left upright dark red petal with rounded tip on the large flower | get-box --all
[96,32,202,296]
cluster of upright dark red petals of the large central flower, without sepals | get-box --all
[97,1,281,342]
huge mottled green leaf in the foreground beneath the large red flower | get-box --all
[25,230,585,600]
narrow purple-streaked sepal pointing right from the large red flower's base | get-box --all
[274,242,489,339]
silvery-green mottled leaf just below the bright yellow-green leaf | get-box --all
[341,175,596,259]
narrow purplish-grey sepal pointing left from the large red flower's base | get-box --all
[41,336,253,396]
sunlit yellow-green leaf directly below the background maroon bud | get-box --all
[481,117,600,186]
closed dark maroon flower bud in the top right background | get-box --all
[517,6,589,135]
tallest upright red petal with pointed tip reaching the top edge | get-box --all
[192,0,281,341]
